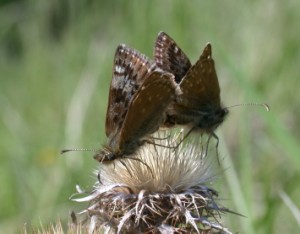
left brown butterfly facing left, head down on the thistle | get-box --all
[94,45,176,163]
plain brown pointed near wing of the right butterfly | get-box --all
[179,43,220,109]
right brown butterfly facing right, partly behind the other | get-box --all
[154,32,228,146]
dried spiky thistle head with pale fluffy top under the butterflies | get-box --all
[74,133,230,233]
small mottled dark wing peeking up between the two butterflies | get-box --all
[154,32,191,83]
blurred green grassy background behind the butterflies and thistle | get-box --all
[0,0,300,233]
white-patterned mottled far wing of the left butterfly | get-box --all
[105,44,155,138]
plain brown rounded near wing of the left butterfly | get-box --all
[119,71,176,145]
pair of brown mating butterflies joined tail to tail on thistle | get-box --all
[95,32,228,163]
